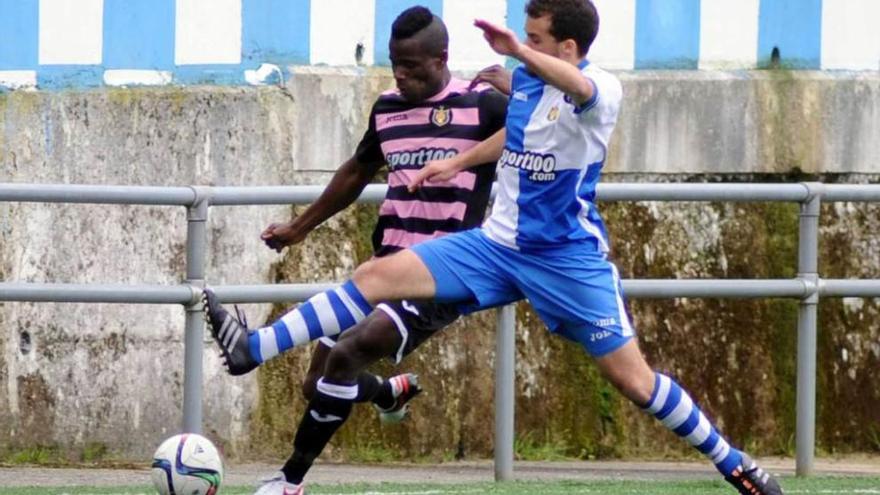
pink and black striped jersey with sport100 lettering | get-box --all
[355,78,507,256]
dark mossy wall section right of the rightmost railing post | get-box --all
[816,199,880,453]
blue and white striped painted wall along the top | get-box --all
[0,0,880,88]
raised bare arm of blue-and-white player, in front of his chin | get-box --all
[474,19,595,105]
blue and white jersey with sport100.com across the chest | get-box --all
[483,61,623,251]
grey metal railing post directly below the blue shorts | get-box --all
[495,304,516,481]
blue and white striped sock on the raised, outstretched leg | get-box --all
[248,280,373,363]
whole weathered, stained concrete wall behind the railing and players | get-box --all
[0,68,880,459]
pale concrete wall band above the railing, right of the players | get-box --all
[607,71,880,174]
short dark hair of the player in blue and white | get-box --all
[526,0,599,56]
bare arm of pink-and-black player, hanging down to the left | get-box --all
[260,157,381,253]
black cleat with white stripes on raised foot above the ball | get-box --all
[202,289,260,376]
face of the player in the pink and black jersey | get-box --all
[388,35,446,103]
